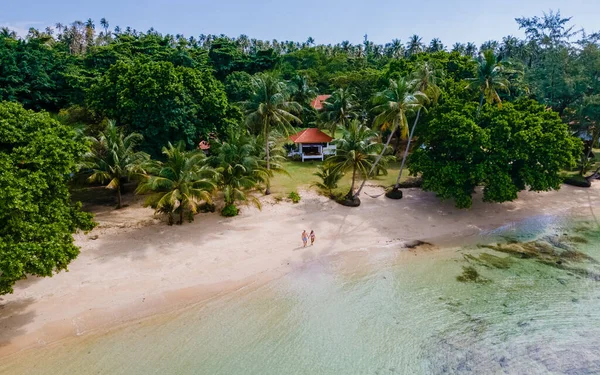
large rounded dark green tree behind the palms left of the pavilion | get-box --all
[88,59,237,156]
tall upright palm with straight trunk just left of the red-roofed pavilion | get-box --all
[244,74,302,195]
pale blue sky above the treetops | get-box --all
[0,0,600,46]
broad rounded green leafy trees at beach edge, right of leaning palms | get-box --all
[410,100,580,207]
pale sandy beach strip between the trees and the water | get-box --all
[0,184,600,357]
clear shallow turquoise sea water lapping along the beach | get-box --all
[0,216,600,374]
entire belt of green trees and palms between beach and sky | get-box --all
[0,12,600,293]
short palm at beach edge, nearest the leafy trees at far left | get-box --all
[83,120,150,208]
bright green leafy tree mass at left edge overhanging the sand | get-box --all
[0,102,94,294]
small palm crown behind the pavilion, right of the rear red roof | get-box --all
[321,88,358,137]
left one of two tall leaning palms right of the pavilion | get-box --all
[356,78,427,196]
